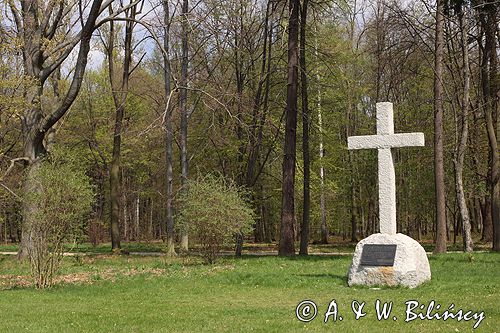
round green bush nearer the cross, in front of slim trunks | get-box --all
[180,175,254,263]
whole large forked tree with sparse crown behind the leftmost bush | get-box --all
[8,0,112,257]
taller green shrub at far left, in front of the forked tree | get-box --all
[25,159,94,288]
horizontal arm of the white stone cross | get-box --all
[347,133,425,149]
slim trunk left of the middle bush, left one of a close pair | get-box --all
[163,0,176,257]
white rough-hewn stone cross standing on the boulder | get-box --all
[347,102,425,235]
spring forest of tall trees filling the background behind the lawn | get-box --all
[0,0,500,252]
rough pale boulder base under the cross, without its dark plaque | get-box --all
[348,233,431,288]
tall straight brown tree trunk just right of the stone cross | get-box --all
[434,0,446,253]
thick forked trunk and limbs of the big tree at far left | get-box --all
[16,0,102,259]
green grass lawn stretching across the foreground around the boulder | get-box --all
[0,253,500,332]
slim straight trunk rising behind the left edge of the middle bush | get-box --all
[179,0,189,252]
